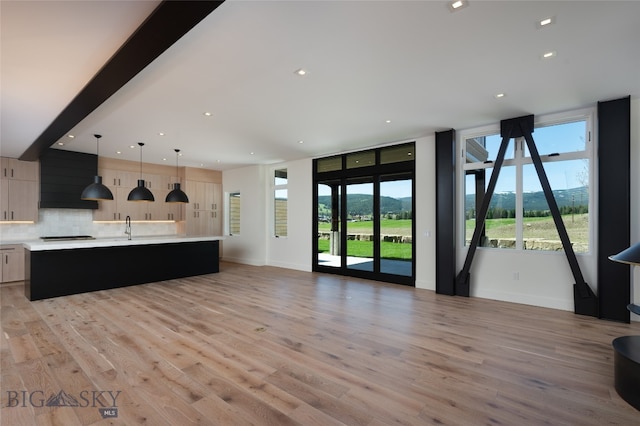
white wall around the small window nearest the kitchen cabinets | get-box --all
[222,166,267,266]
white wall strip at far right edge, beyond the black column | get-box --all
[630,98,640,322]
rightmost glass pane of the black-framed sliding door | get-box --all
[379,176,413,276]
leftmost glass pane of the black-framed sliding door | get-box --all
[316,181,341,268]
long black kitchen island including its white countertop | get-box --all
[24,236,223,300]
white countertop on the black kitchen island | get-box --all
[22,235,224,251]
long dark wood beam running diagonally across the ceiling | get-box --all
[20,0,224,161]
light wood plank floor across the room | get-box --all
[0,263,640,426]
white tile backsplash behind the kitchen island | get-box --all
[0,209,178,241]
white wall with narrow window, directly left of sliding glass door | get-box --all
[265,158,313,272]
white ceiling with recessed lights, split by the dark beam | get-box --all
[0,0,640,170]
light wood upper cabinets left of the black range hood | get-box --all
[0,157,38,222]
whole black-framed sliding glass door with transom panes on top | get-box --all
[313,144,415,285]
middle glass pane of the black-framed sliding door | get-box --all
[346,178,374,272]
